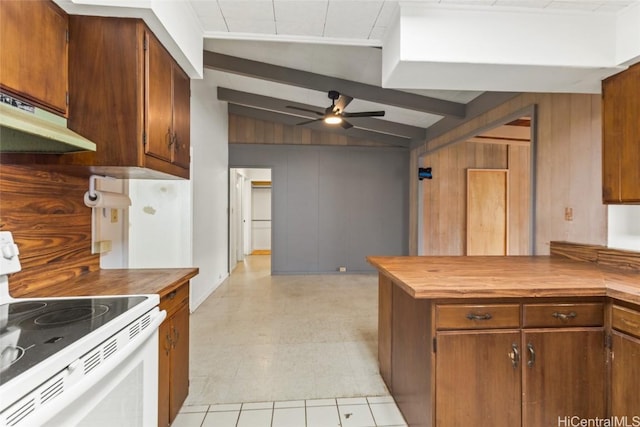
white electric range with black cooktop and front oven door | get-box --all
[0,231,166,427]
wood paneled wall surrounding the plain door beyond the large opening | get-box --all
[420,142,530,255]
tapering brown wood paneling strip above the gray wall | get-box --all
[229,114,396,147]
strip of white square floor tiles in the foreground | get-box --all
[173,396,407,427]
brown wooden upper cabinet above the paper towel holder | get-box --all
[66,15,190,179]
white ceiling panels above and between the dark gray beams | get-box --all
[190,0,640,144]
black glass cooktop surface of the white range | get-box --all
[0,296,147,385]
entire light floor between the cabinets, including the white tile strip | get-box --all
[173,255,405,427]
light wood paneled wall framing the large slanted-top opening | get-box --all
[409,93,607,255]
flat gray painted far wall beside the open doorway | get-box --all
[229,144,409,274]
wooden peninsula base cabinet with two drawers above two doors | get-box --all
[378,284,612,427]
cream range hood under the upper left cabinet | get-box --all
[0,94,96,154]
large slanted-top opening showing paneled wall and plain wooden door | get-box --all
[418,110,536,255]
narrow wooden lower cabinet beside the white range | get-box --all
[158,282,189,427]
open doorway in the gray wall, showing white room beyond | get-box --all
[229,168,272,272]
